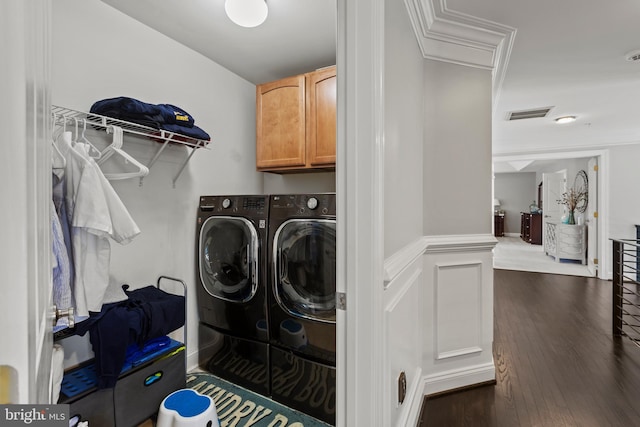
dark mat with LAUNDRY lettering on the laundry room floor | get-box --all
[187,372,330,427]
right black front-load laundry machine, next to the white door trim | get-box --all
[268,194,336,424]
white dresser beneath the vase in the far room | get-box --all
[544,222,587,265]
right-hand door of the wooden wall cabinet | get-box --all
[307,67,337,167]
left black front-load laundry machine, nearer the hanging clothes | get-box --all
[196,195,270,396]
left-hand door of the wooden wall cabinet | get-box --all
[256,75,306,170]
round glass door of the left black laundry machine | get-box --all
[198,216,258,302]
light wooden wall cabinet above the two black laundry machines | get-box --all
[256,66,337,173]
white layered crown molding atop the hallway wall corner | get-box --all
[405,0,517,99]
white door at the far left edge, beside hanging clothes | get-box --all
[0,0,53,404]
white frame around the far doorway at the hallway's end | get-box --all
[493,149,613,280]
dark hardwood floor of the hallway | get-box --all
[419,270,640,427]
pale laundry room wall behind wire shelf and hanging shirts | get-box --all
[52,0,263,366]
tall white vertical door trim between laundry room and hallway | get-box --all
[336,0,385,427]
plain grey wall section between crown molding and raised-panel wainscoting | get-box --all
[424,60,493,235]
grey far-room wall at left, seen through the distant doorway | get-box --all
[493,172,538,234]
